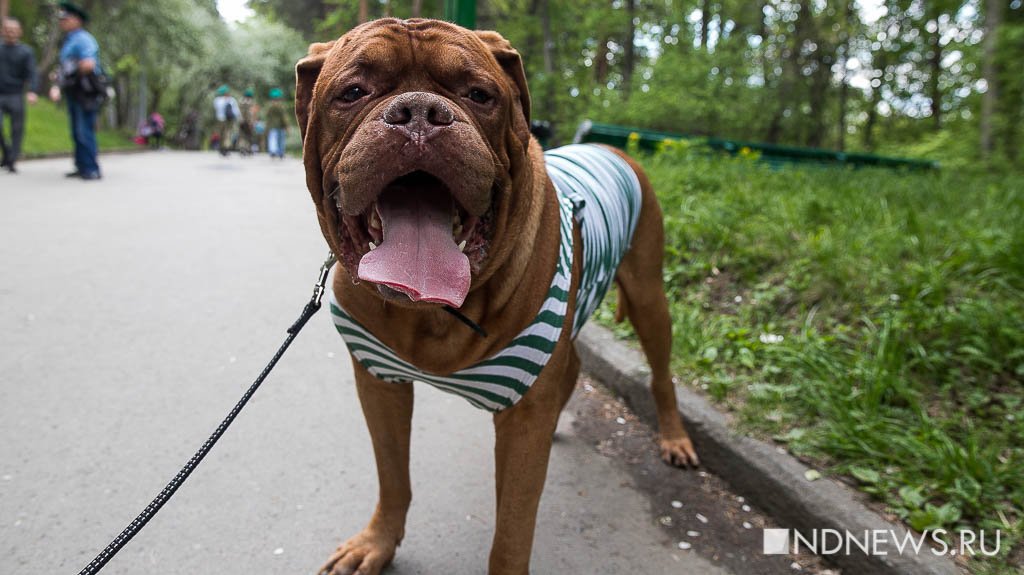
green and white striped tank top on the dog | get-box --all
[331,144,640,411]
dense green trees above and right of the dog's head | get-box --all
[251,0,1024,166]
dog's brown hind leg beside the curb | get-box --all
[615,154,698,467]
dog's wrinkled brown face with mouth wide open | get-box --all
[296,18,529,307]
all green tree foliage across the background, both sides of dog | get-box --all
[11,0,1024,167]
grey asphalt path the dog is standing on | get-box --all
[0,151,745,575]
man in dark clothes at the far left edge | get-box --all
[0,18,39,174]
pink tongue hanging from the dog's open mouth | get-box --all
[359,186,470,308]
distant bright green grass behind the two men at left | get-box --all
[22,99,137,158]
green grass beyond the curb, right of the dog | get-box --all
[600,141,1024,573]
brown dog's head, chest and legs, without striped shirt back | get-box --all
[295,18,697,575]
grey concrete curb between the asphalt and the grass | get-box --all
[577,323,962,575]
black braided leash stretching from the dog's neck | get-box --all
[79,254,335,575]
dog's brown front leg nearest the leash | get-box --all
[319,361,413,575]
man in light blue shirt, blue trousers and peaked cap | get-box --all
[50,2,103,180]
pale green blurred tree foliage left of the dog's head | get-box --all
[11,0,306,139]
